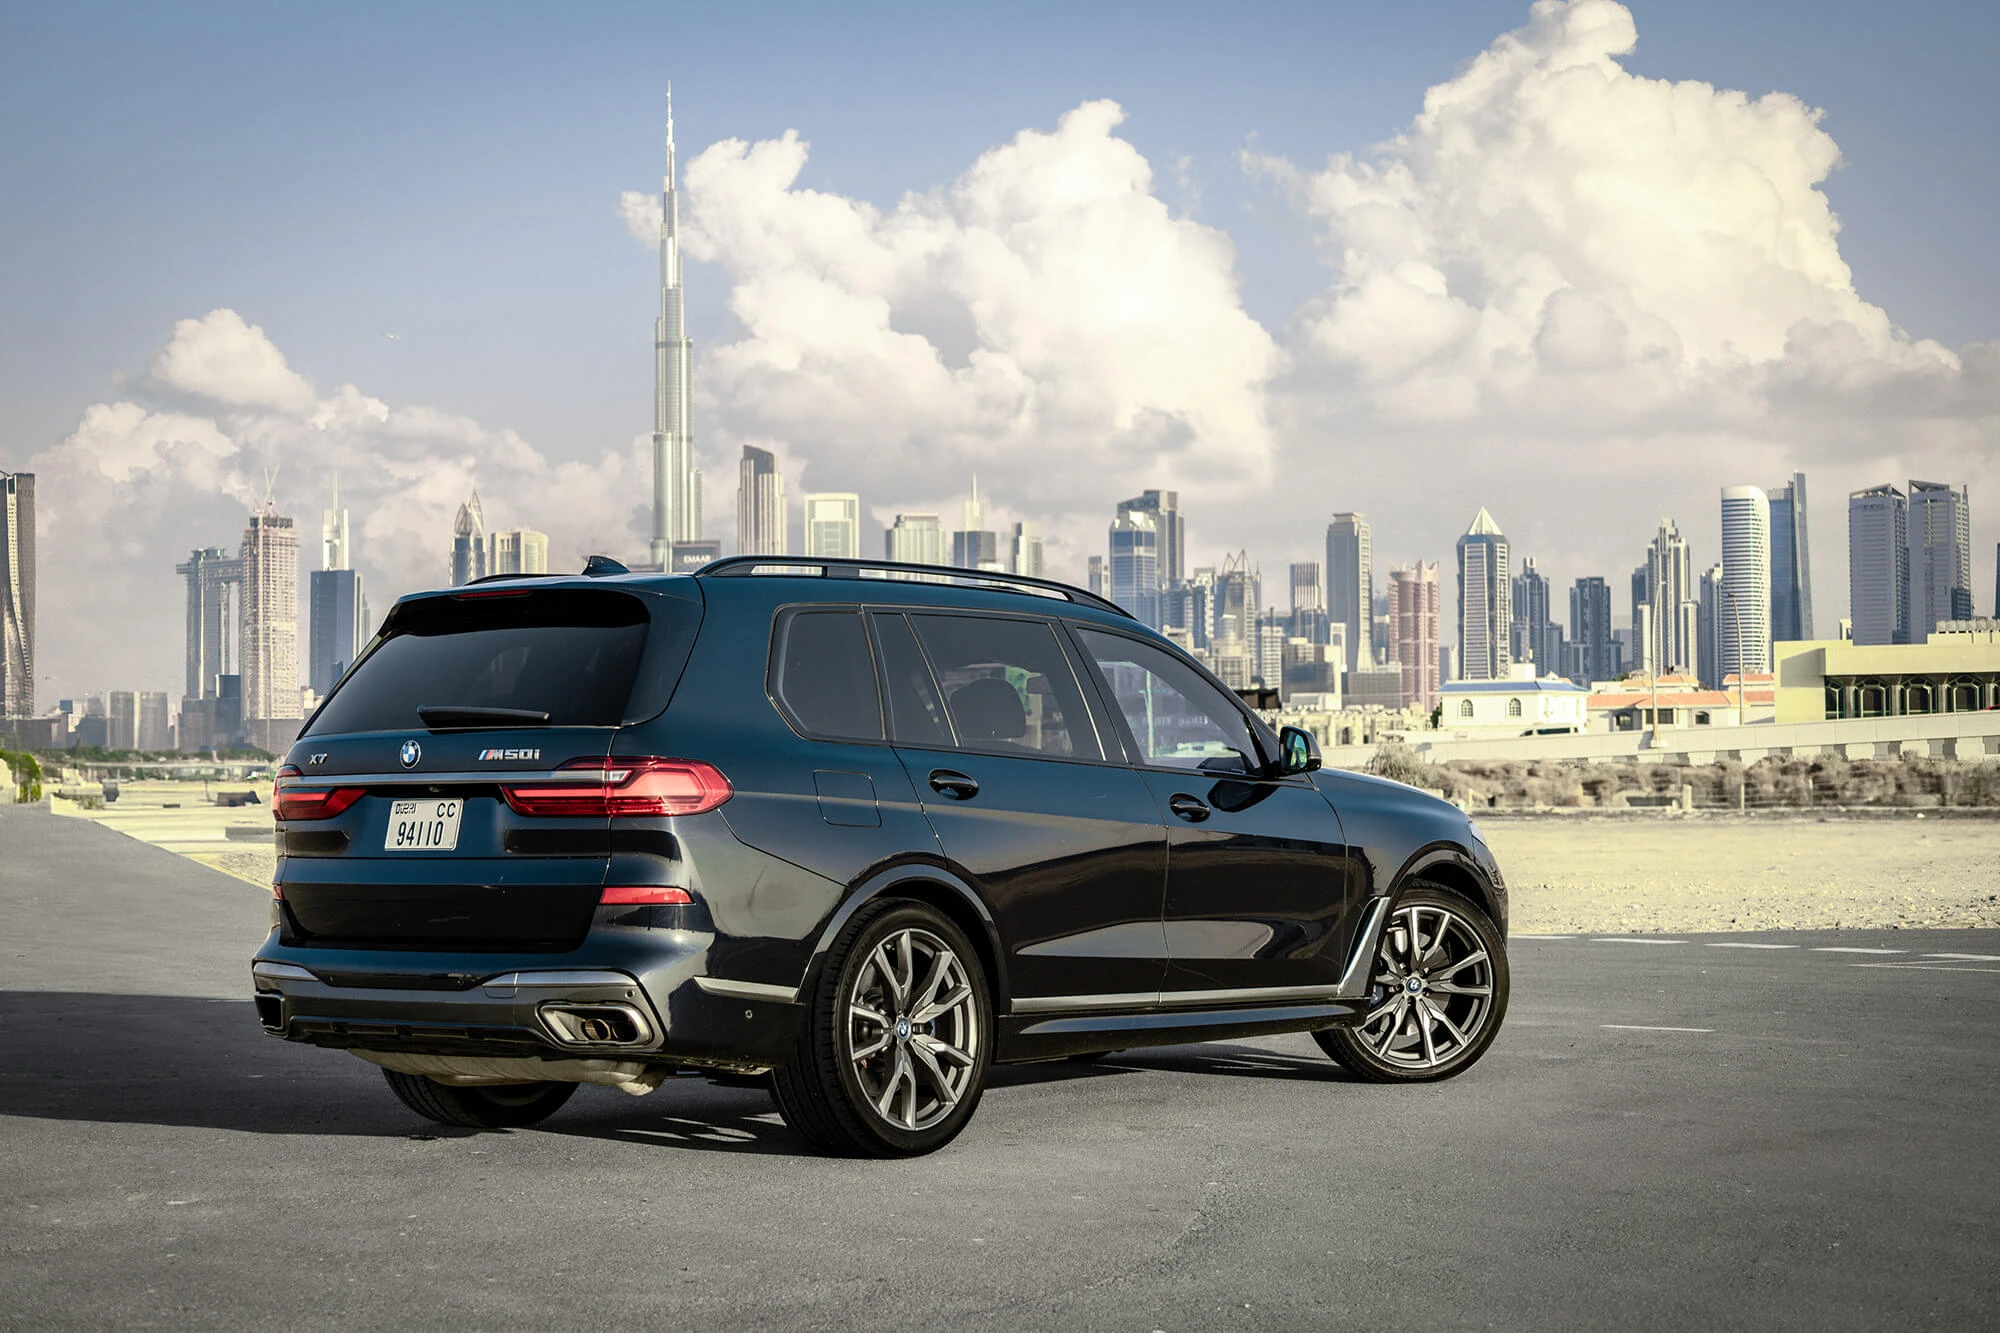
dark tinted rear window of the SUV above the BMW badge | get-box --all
[308,588,664,735]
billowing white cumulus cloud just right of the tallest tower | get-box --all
[672,102,1282,564]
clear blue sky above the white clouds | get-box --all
[0,0,2000,458]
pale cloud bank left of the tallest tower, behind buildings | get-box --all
[26,310,650,703]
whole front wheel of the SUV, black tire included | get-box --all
[1312,881,1508,1083]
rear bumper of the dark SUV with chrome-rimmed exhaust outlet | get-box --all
[252,931,800,1073]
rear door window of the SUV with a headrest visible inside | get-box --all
[910,614,1104,759]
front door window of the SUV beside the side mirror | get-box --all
[1076,628,1258,773]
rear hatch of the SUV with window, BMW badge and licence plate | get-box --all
[274,578,700,951]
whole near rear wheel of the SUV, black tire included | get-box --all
[770,901,994,1157]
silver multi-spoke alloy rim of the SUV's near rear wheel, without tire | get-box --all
[842,927,980,1133]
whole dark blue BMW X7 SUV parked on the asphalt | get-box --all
[252,556,1508,1157]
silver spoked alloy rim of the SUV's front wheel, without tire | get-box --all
[1354,903,1494,1071]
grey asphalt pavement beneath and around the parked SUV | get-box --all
[0,807,2000,1329]
